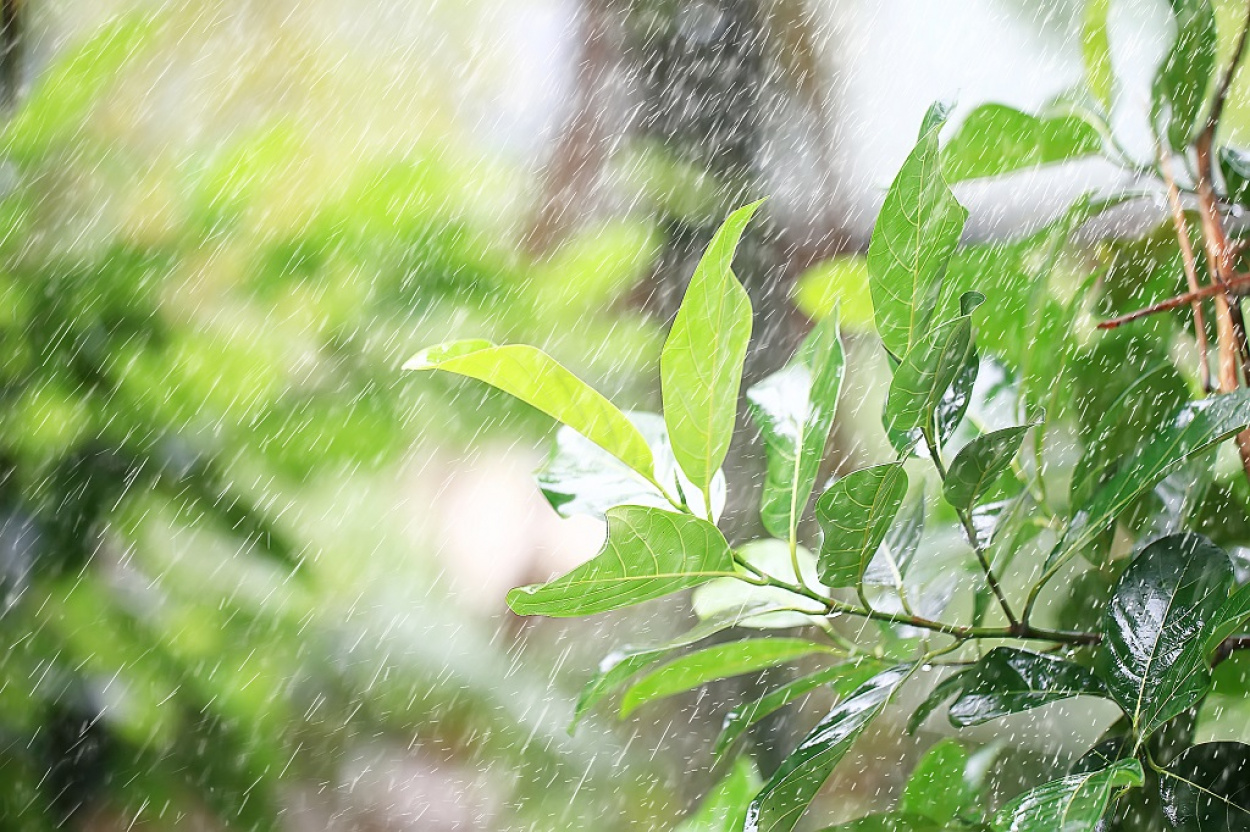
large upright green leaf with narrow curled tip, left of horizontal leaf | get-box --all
[868,103,968,356]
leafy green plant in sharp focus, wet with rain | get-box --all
[405,0,1250,832]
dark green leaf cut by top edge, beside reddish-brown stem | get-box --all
[1150,0,1215,150]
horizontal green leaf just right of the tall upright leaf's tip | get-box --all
[943,104,1103,182]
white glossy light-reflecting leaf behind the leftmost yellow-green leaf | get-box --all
[534,411,725,520]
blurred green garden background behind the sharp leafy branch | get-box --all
[7,0,1250,832]
